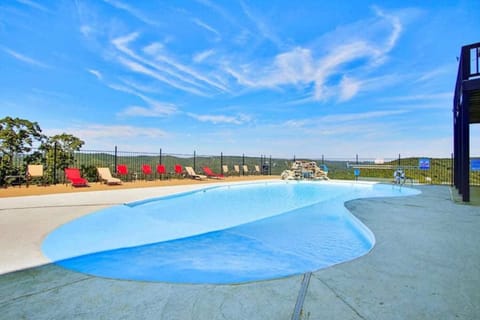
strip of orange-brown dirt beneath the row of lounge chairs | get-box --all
[0,176,279,198]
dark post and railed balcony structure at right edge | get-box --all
[453,42,480,202]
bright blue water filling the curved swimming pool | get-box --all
[42,182,419,284]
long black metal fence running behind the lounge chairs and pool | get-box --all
[0,147,480,185]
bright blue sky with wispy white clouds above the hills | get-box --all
[0,0,480,158]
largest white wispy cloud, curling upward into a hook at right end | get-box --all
[225,6,402,102]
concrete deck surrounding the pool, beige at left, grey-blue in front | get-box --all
[0,184,480,319]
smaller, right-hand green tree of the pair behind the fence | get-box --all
[40,133,85,182]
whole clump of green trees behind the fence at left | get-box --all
[0,116,85,185]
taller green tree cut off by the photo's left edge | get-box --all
[0,117,45,183]
